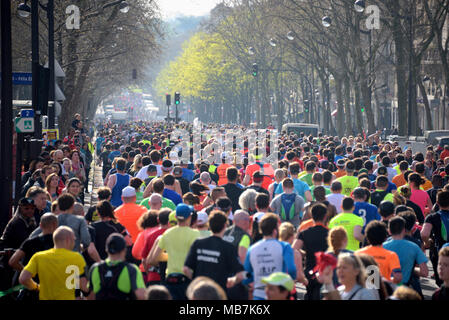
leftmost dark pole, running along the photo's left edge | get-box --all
[0,1,13,233]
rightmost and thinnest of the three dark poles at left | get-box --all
[47,0,56,129]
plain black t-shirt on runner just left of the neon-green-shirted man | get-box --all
[298,225,329,272]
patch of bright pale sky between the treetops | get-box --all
[157,0,221,19]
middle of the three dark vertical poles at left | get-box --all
[31,0,41,139]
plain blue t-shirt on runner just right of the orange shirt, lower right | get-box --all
[383,239,428,284]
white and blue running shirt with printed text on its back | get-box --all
[244,239,296,300]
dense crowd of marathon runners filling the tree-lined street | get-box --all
[0,115,449,300]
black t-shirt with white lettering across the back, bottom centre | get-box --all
[184,236,244,290]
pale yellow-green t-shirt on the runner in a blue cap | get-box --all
[158,226,200,276]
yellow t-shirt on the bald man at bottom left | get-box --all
[24,248,86,300]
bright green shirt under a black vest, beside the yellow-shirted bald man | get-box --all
[89,258,145,293]
